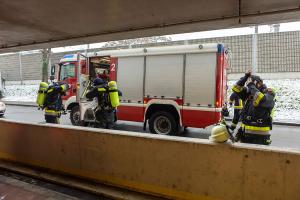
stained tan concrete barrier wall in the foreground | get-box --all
[0,120,300,200]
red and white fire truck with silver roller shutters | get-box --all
[53,44,227,134]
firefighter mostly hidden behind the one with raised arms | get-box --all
[229,92,243,130]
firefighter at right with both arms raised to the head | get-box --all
[232,71,275,145]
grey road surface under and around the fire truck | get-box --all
[4,105,300,149]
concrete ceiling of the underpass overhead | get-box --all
[0,0,300,52]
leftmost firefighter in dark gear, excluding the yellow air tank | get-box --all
[43,83,69,124]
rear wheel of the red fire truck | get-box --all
[149,111,178,135]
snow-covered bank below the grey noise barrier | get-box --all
[2,79,300,122]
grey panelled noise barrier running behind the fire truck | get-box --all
[0,31,300,81]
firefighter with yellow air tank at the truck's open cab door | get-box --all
[86,78,119,129]
